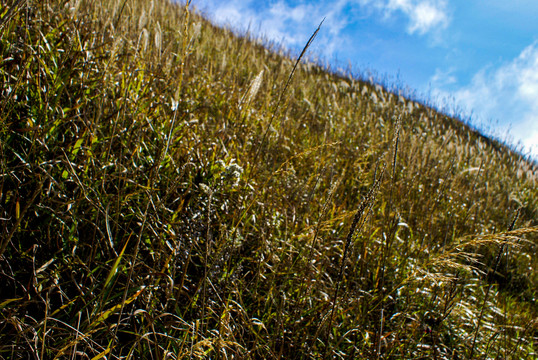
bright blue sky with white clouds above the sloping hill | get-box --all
[191,0,538,159]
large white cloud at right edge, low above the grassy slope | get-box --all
[432,41,538,159]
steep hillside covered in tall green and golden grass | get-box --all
[0,0,538,359]
